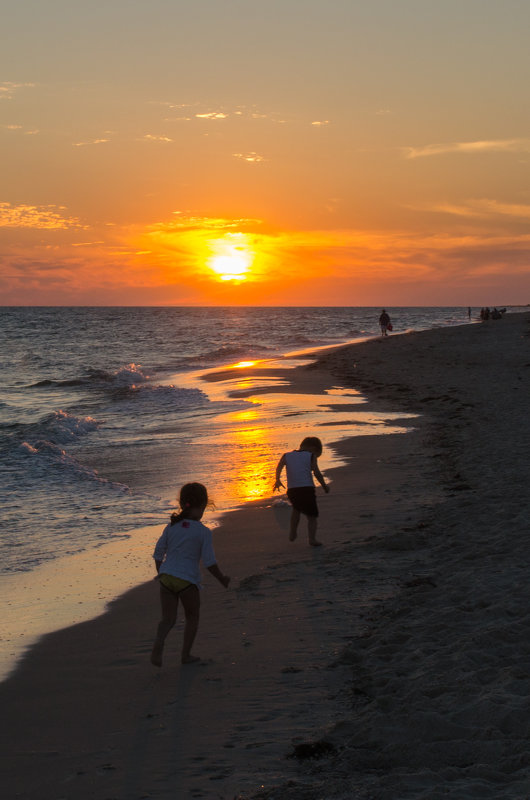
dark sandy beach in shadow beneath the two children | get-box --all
[0,313,530,800]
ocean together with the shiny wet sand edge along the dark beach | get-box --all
[0,307,492,680]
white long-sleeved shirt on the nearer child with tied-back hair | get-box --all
[153,519,217,586]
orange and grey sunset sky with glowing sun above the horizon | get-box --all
[0,0,530,306]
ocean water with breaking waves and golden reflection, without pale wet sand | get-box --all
[0,307,478,573]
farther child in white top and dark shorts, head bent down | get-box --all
[274,436,329,547]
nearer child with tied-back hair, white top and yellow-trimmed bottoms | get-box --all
[151,483,230,667]
